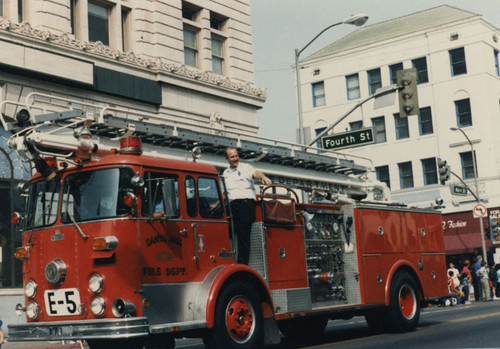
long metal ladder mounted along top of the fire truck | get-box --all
[0,92,388,203]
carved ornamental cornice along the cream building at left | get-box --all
[0,19,267,101]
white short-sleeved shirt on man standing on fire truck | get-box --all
[226,162,255,201]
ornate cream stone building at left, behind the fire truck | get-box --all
[0,0,266,323]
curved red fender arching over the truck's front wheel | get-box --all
[206,263,274,328]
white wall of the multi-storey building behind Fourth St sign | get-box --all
[301,18,500,212]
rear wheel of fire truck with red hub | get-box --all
[387,272,420,332]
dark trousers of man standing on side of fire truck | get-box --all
[231,199,255,264]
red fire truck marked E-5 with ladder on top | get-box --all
[2,96,448,348]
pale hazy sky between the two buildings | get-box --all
[250,0,500,142]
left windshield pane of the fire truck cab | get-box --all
[26,176,61,229]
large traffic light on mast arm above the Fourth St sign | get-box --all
[396,68,420,117]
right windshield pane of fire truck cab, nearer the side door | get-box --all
[61,168,134,223]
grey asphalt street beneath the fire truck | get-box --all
[2,300,500,349]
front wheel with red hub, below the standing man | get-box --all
[203,281,264,349]
